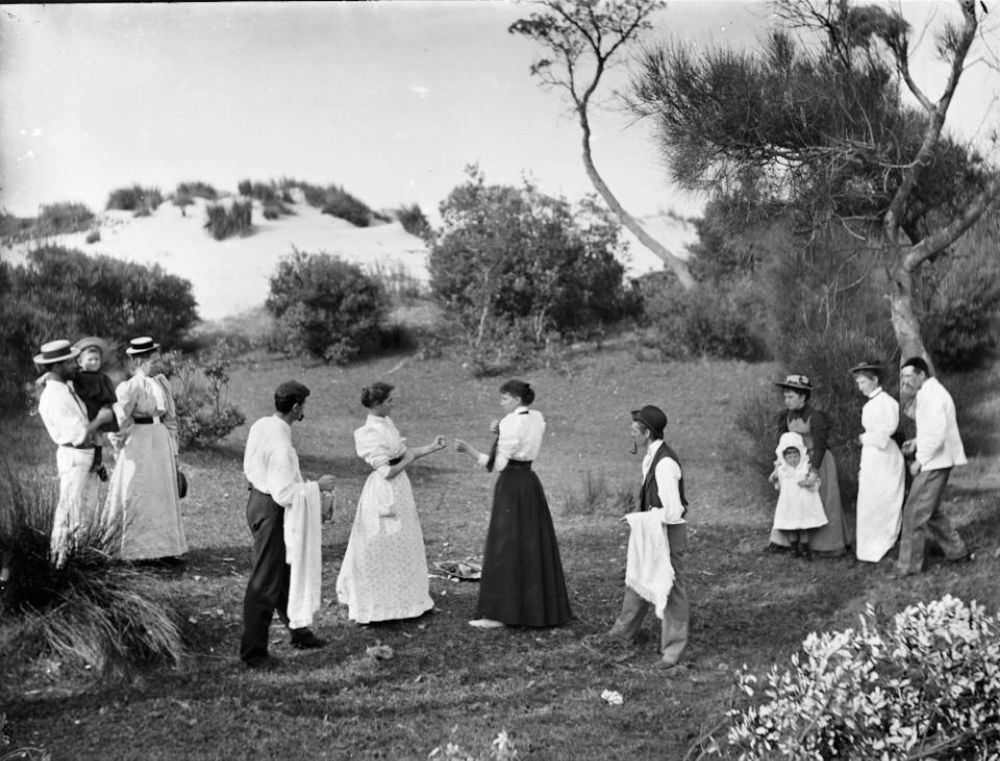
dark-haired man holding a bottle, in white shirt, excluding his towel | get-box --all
[240,381,334,668]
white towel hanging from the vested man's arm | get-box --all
[625,507,674,618]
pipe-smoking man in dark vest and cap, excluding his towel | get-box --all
[608,405,690,667]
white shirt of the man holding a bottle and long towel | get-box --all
[243,415,306,509]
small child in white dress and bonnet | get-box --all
[768,432,827,560]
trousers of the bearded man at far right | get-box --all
[896,468,968,573]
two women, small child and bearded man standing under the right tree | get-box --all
[770,357,971,576]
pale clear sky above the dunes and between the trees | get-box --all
[0,0,1000,223]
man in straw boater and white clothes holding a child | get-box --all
[34,339,113,566]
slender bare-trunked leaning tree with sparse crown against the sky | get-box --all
[508,0,694,288]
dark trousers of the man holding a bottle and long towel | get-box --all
[240,489,291,661]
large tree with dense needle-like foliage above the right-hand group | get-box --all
[632,0,1000,366]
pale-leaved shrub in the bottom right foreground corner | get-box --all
[709,595,1000,761]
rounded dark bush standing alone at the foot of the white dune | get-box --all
[266,249,389,363]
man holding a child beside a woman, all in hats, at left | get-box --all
[34,336,187,566]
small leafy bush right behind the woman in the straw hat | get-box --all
[161,342,246,450]
